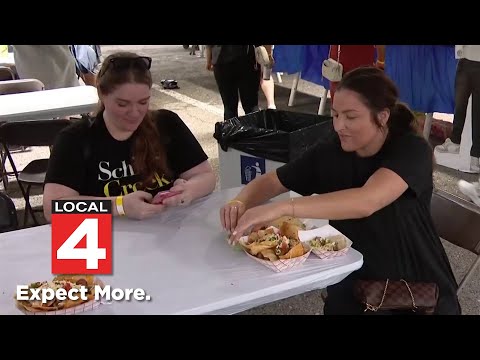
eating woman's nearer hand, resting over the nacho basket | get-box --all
[229,203,289,244]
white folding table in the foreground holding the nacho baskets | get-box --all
[0,188,363,315]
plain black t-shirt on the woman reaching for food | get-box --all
[277,133,458,313]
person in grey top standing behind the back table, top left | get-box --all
[12,45,80,90]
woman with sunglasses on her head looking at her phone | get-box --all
[43,52,216,219]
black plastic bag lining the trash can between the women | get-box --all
[213,109,336,163]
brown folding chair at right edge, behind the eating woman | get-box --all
[431,189,480,293]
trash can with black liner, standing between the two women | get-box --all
[214,109,335,194]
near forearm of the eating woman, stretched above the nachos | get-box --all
[279,188,373,220]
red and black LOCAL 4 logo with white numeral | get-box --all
[52,200,112,274]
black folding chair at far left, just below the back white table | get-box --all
[0,119,72,226]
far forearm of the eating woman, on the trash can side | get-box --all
[235,171,288,208]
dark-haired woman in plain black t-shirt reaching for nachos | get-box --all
[220,67,460,314]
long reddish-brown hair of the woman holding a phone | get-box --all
[97,52,170,183]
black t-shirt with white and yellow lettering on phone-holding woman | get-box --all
[45,110,208,196]
